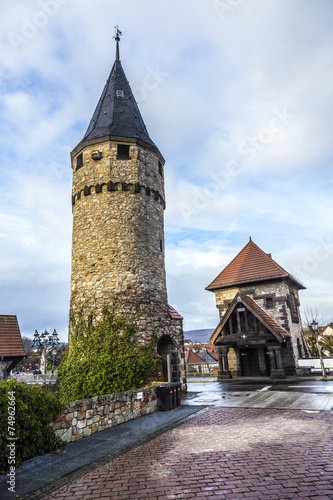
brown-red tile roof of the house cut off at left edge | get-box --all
[0,314,25,357]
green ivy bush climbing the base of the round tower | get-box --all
[58,308,157,402]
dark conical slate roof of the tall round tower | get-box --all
[81,59,157,149]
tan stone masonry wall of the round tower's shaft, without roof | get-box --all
[71,141,167,340]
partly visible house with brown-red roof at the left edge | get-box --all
[0,314,26,380]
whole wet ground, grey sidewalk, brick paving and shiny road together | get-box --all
[4,378,333,500]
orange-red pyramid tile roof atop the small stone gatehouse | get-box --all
[206,240,305,291]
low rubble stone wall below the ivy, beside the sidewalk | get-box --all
[51,387,159,443]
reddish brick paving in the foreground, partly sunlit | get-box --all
[44,408,333,500]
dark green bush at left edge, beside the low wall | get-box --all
[0,379,63,472]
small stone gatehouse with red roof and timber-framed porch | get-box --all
[206,238,309,378]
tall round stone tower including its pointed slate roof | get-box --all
[71,32,185,383]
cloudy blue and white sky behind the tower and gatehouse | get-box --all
[0,0,333,340]
